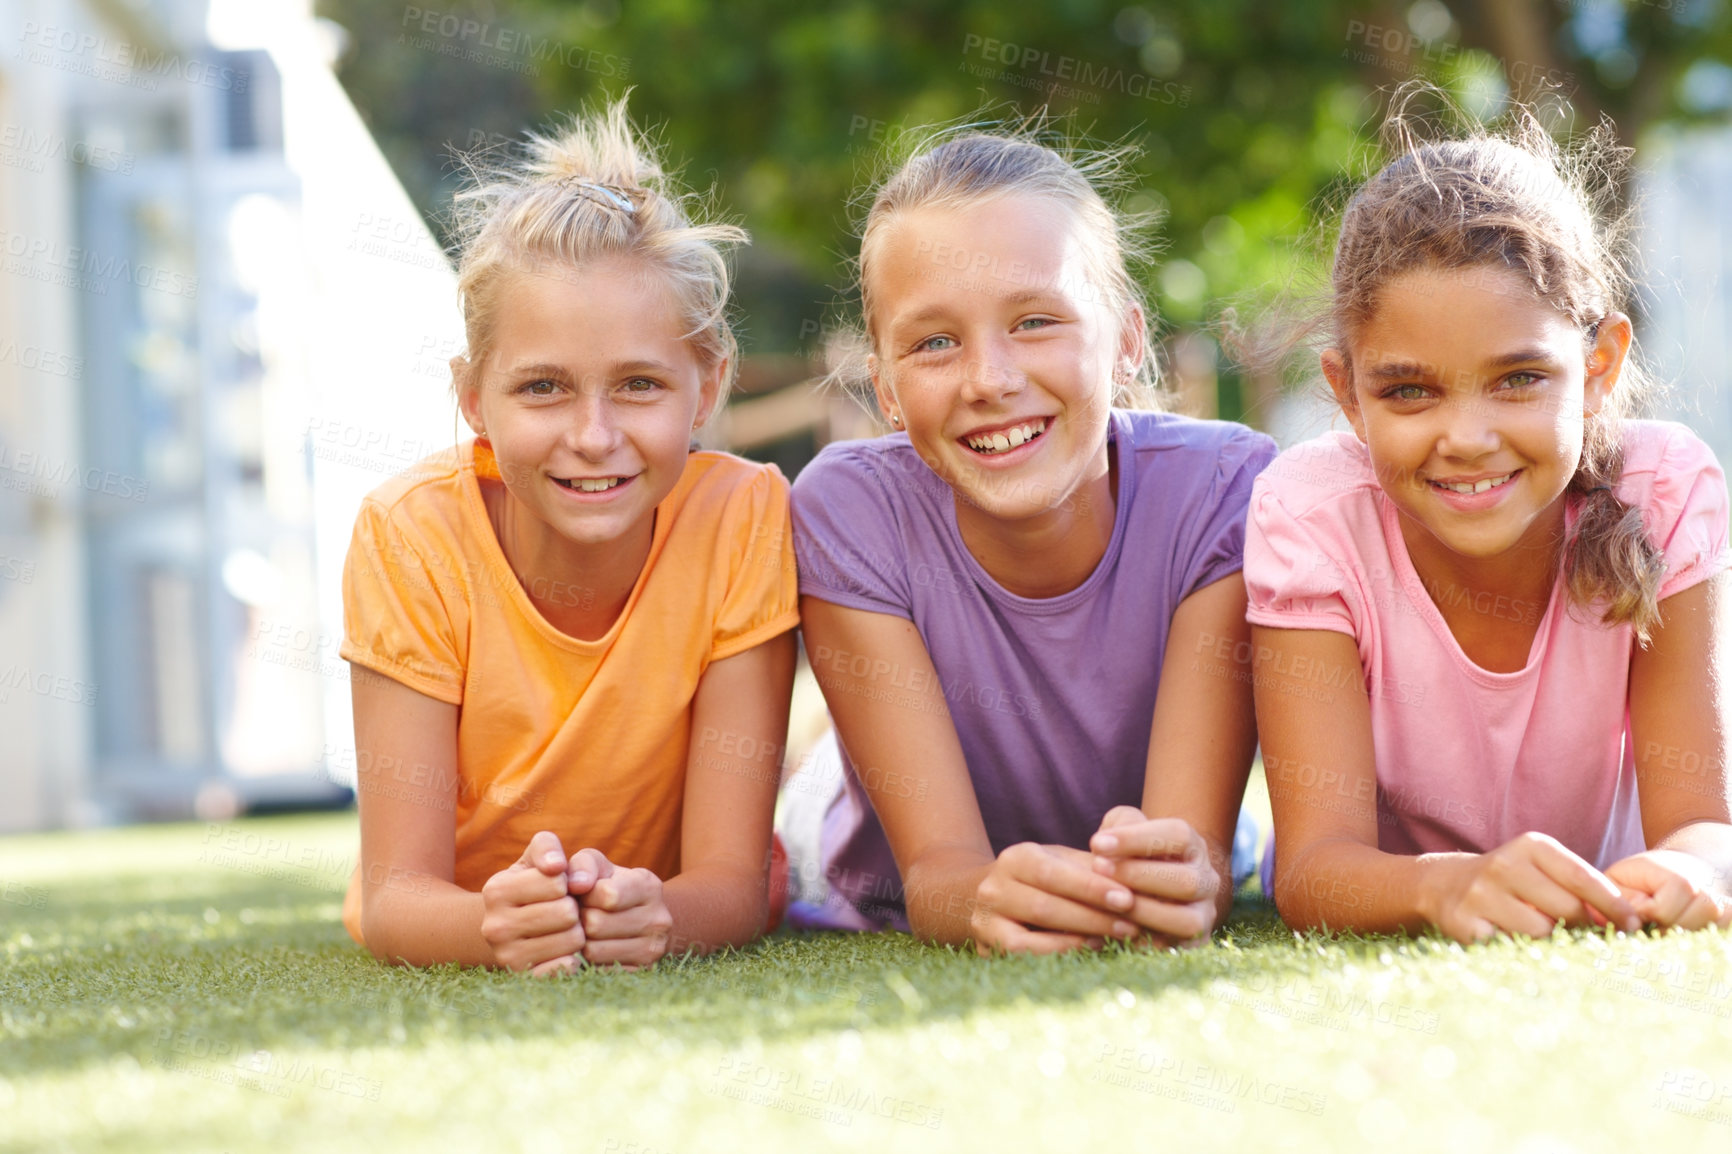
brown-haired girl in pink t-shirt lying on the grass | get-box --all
[1240,98,1732,941]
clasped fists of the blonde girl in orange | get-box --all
[481,830,674,977]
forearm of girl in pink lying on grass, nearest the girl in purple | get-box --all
[1275,840,1479,934]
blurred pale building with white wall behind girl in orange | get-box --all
[0,0,461,830]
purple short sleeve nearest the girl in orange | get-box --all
[793,444,927,619]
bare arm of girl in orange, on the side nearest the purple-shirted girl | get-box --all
[663,629,795,953]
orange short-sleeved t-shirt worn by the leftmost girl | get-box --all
[341,440,798,941]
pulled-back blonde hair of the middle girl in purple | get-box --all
[837,118,1160,409]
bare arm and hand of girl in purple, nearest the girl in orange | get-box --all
[800,598,1134,951]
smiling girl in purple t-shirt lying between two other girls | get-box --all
[793,125,1273,953]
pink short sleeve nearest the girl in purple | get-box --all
[1245,473,1358,636]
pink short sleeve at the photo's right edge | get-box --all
[1644,426,1732,598]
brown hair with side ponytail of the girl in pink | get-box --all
[1325,85,1664,643]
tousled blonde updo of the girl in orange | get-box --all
[452,99,748,409]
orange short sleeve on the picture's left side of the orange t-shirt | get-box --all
[339,499,466,705]
